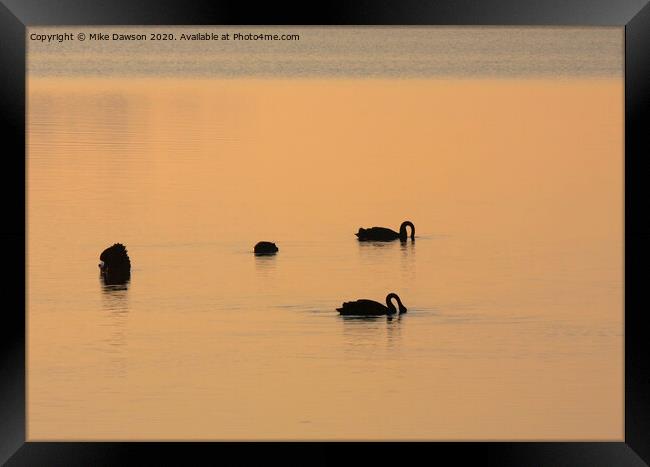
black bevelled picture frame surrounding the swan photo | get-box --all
[0,0,650,467]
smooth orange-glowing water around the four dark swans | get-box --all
[27,78,623,440]
